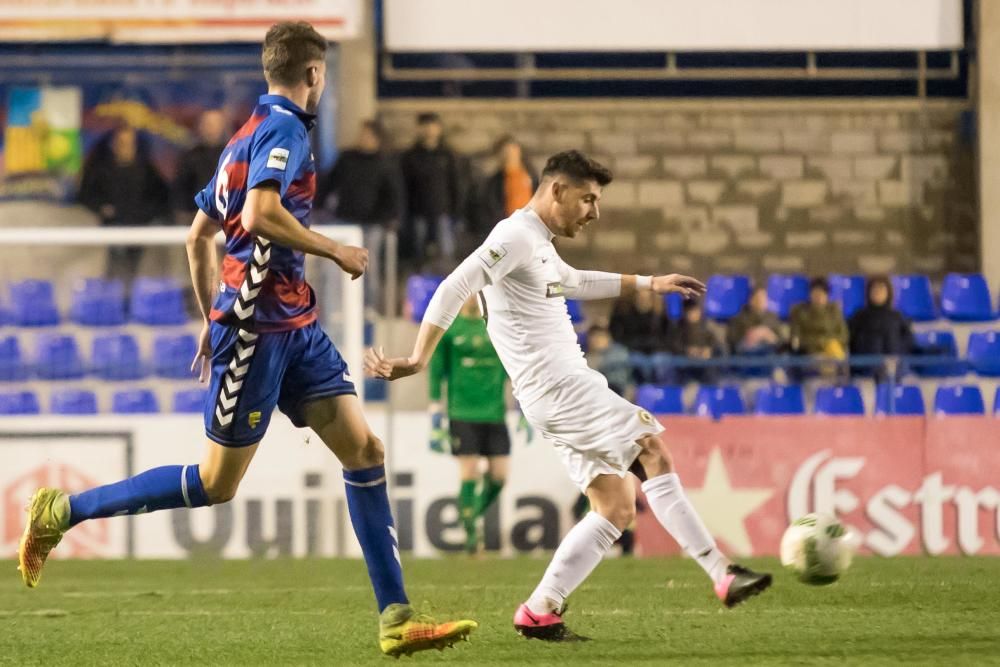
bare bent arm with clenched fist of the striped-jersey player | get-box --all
[240,187,368,280]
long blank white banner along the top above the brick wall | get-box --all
[384,0,963,53]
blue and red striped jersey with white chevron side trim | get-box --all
[195,95,316,332]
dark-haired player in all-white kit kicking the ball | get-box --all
[365,151,771,641]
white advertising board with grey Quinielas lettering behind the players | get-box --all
[0,410,578,558]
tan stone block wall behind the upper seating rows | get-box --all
[379,100,979,278]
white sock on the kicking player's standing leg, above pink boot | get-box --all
[527,512,622,614]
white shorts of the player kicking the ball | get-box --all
[521,369,663,492]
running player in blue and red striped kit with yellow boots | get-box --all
[18,22,476,656]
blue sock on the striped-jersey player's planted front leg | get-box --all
[344,466,409,613]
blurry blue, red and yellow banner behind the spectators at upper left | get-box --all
[0,47,266,201]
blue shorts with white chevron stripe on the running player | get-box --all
[205,322,357,447]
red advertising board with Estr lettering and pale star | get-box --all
[637,417,1000,556]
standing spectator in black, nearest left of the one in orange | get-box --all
[400,113,462,263]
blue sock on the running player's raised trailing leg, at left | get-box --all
[69,466,208,526]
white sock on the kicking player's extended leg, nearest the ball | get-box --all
[642,472,730,583]
